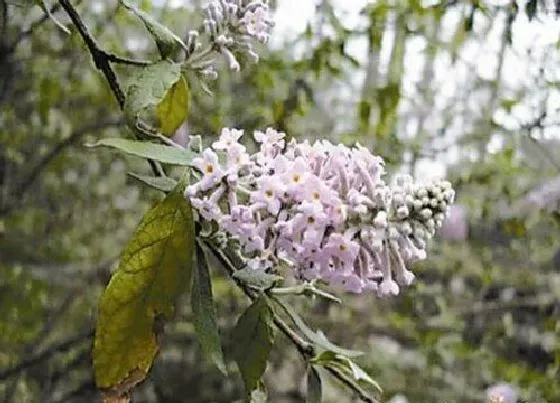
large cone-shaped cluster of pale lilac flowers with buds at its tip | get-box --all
[185,128,455,296]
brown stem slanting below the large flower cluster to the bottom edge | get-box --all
[204,242,379,403]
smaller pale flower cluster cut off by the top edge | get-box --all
[204,0,273,70]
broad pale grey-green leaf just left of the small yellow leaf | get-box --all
[124,60,182,125]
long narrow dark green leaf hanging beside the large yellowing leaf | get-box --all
[191,243,227,375]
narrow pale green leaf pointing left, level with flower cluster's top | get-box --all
[88,138,197,166]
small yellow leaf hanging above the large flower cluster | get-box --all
[156,76,189,136]
